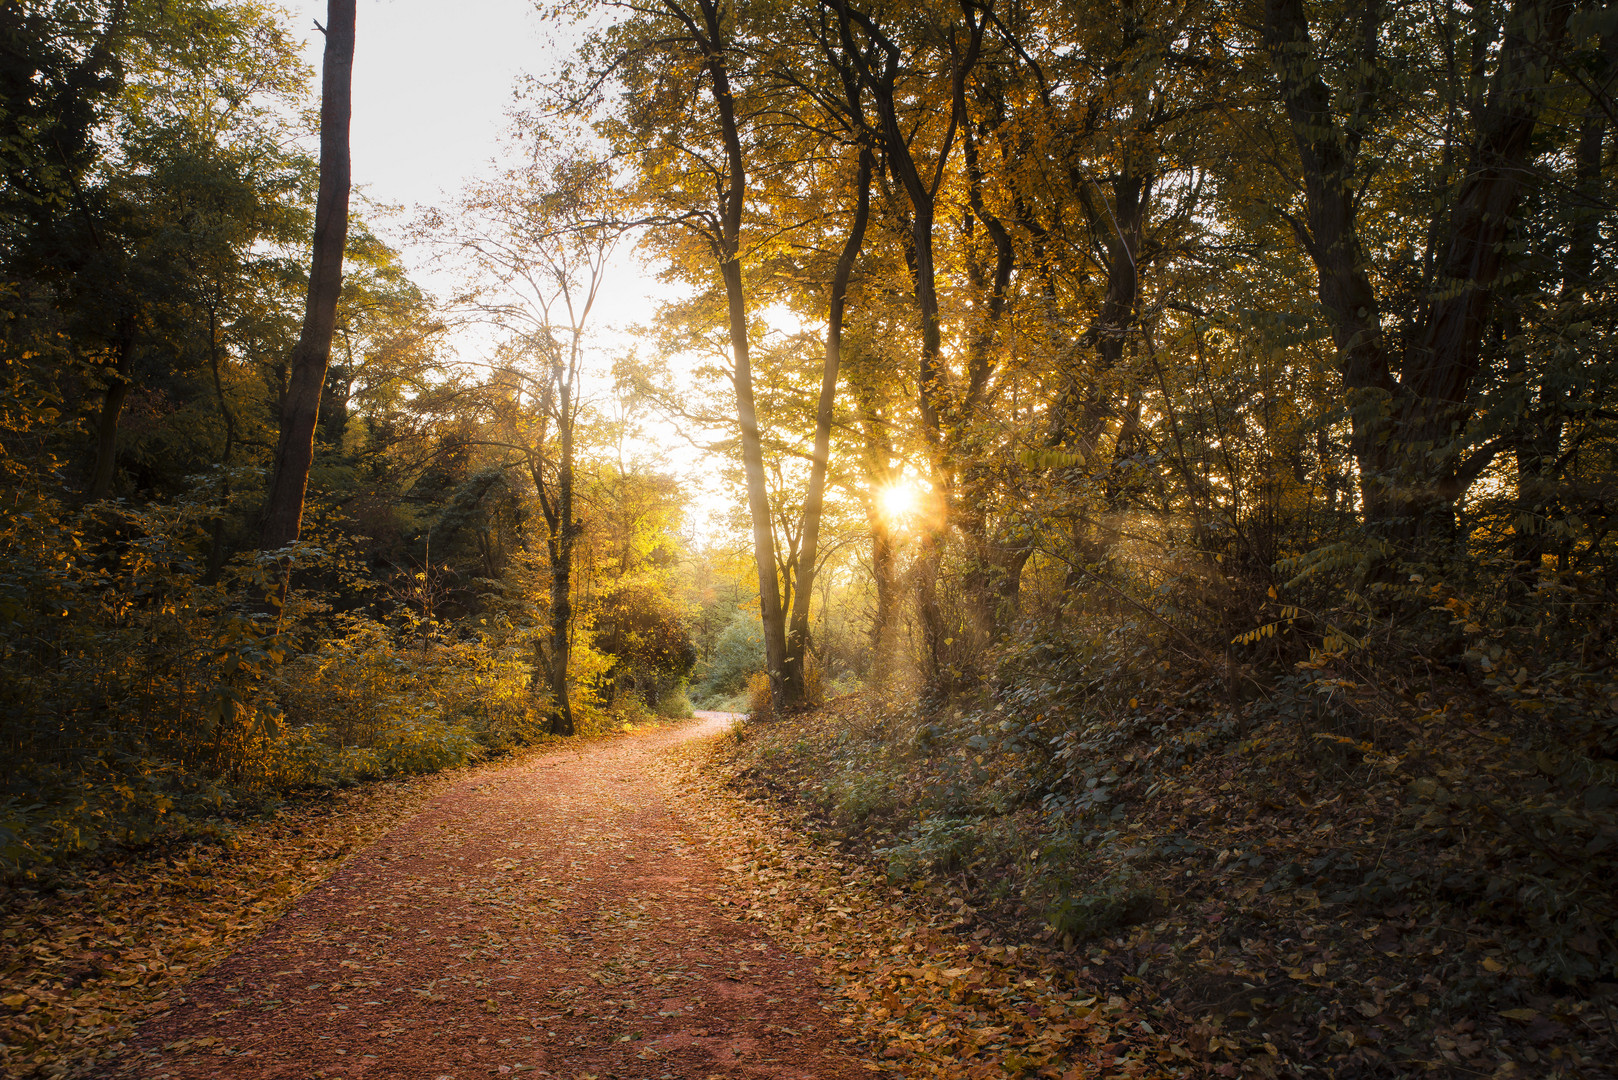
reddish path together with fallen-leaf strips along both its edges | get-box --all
[0,714,1150,1080]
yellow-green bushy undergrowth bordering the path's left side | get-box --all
[0,482,540,871]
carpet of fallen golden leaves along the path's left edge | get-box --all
[0,771,461,1077]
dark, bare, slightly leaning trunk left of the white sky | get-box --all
[259,0,356,549]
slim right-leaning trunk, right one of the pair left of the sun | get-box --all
[781,146,875,708]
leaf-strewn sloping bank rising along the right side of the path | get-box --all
[714,691,1618,1077]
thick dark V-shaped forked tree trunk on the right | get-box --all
[1264,0,1573,549]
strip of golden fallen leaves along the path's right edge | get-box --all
[665,725,1192,1080]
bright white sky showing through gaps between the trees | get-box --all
[286,0,728,538]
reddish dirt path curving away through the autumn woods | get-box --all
[125,712,869,1080]
